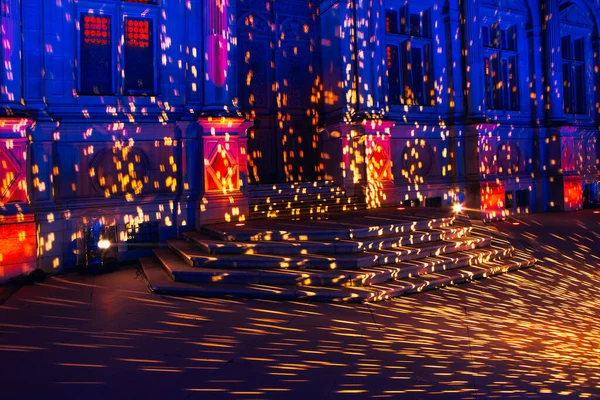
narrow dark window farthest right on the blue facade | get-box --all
[561,35,586,114]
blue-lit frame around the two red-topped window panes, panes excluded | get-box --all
[75,0,161,98]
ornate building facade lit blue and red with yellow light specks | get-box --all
[0,0,600,281]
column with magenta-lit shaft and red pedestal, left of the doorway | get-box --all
[198,0,252,227]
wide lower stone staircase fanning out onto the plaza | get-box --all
[140,208,535,302]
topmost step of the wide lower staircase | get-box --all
[202,214,454,242]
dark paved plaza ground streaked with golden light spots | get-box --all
[0,210,600,399]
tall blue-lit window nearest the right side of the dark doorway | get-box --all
[385,6,435,106]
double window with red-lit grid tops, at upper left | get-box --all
[78,0,156,95]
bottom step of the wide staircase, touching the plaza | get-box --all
[140,250,535,302]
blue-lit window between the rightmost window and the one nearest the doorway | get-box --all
[481,23,519,111]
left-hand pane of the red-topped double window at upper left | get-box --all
[79,13,113,94]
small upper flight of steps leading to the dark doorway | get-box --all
[248,181,365,219]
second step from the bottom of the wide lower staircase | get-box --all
[154,246,514,287]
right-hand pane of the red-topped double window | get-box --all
[125,18,154,93]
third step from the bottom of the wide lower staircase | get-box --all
[167,235,492,270]
